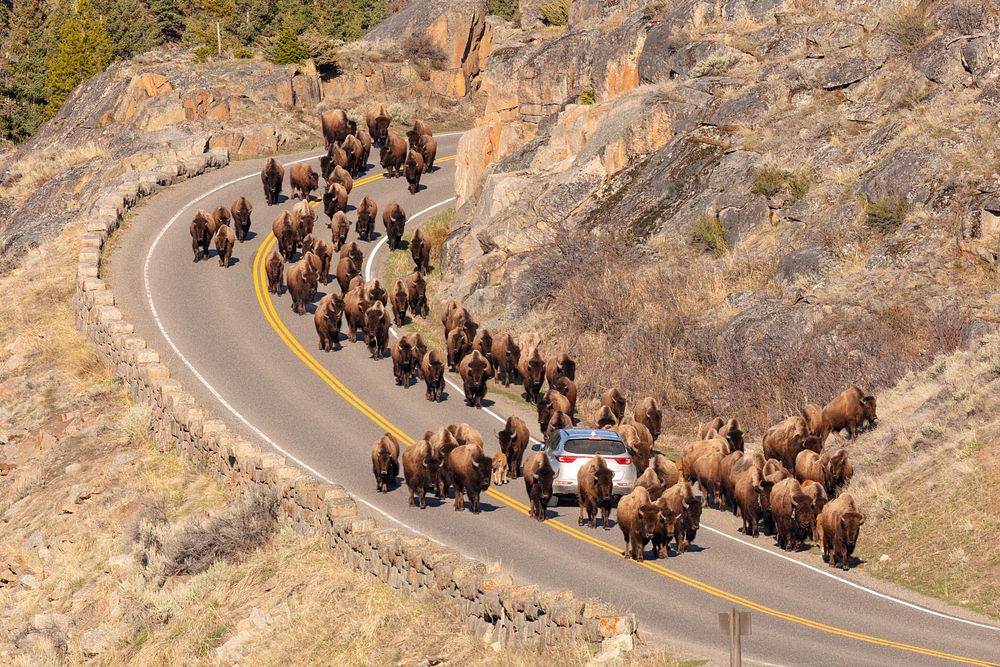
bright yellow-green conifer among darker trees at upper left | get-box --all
[47,0,112,114]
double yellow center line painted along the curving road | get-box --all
[253,155,1000,667]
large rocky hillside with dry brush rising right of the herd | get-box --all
[444,0,1000,433]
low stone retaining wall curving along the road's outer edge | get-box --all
[74,149,636,651]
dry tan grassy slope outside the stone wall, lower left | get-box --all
[0,231,678,665]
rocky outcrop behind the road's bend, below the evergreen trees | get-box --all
[0,1,492,272]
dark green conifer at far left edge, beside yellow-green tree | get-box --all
[0,0,49,141]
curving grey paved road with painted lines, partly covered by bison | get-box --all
[108,136,1000,666]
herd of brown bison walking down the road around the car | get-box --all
[184,107,876,569]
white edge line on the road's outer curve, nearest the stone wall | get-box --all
[142,150,471,558]
